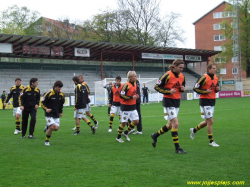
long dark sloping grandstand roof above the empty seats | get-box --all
[0,34,220,61]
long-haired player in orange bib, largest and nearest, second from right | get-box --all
[151,59,187,153]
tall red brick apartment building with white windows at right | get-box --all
[193,1,246,80]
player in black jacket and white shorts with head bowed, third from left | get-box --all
[41,81,65,146]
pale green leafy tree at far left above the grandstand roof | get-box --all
[0,5,40,36]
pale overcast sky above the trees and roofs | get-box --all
[0,0,228,48]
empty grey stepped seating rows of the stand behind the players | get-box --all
[0,66,197,94]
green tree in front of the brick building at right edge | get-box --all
[221,0,250,77]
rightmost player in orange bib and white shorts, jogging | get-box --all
[190,64,220,147]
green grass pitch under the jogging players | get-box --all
[0,98,250,187]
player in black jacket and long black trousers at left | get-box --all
[19,78,40,139]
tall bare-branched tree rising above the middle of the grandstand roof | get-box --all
[118,0,160,45]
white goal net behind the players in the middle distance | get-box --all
[95,78,162,105]
